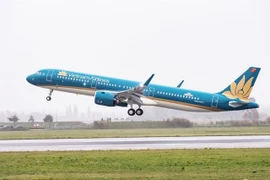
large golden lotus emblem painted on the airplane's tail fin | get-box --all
[222,75,254,100]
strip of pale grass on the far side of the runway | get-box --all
[0,126,270,140]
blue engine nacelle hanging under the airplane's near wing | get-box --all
[95,91,127,107]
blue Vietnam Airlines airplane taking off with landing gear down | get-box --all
[26,67,261,116]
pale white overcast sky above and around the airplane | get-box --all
[0,0,270,112]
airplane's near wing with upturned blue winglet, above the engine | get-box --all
[113,74,155,105]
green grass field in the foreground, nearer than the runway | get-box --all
[0,149,270,180]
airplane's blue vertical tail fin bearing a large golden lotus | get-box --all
[218,67,261,100]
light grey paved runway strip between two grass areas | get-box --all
[0,136,270,152]
